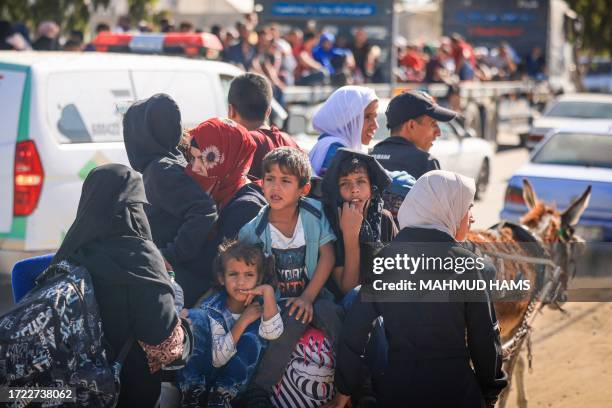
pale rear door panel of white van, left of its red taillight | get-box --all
[0,68,28,234]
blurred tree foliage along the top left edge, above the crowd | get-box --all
[0,0,156,32]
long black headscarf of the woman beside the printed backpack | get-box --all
[52,164,172,291]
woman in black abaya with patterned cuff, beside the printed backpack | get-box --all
[52,164,188,407]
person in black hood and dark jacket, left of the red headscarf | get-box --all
[123,94,217,307]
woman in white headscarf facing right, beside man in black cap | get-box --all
[310,85,378,176]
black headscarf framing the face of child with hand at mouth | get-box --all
[322,148,391,251]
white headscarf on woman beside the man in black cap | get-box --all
[310,85,378,174]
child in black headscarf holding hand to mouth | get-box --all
[322,148,398,298]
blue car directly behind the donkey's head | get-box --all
[500,127,612,242]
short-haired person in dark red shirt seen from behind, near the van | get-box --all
[227,72,299,179]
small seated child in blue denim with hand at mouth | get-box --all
[177,241,283,407]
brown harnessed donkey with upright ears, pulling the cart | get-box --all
[468,180,591,408]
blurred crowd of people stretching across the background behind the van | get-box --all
[0,13,546,98]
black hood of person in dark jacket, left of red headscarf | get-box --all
[123,93,187,173]
